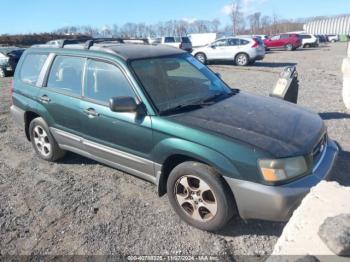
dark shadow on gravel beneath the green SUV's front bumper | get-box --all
[217,217,286,237]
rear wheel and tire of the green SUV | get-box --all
[29,117,66,162]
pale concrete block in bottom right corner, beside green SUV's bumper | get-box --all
[272,181,350,256]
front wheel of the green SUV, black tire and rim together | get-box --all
[167,161,236,231]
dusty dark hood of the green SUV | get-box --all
[169,93,326,158]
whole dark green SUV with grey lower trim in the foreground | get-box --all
[11,43,337,231]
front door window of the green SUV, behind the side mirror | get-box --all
[84,60,135,103]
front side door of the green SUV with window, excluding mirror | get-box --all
[81,59,154,175]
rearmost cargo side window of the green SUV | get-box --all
[20,54,48,85]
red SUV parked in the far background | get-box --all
[264,33,302,51]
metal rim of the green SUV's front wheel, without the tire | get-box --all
[174,175,217,222]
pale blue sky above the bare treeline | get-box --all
[0,0,350,34]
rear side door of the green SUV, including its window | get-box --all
[38,55,86,137]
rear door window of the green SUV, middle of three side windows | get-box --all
[47,56,85,95]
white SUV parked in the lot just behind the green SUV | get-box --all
[192,37,265,66]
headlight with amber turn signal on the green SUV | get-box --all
[258,156,307,182]
